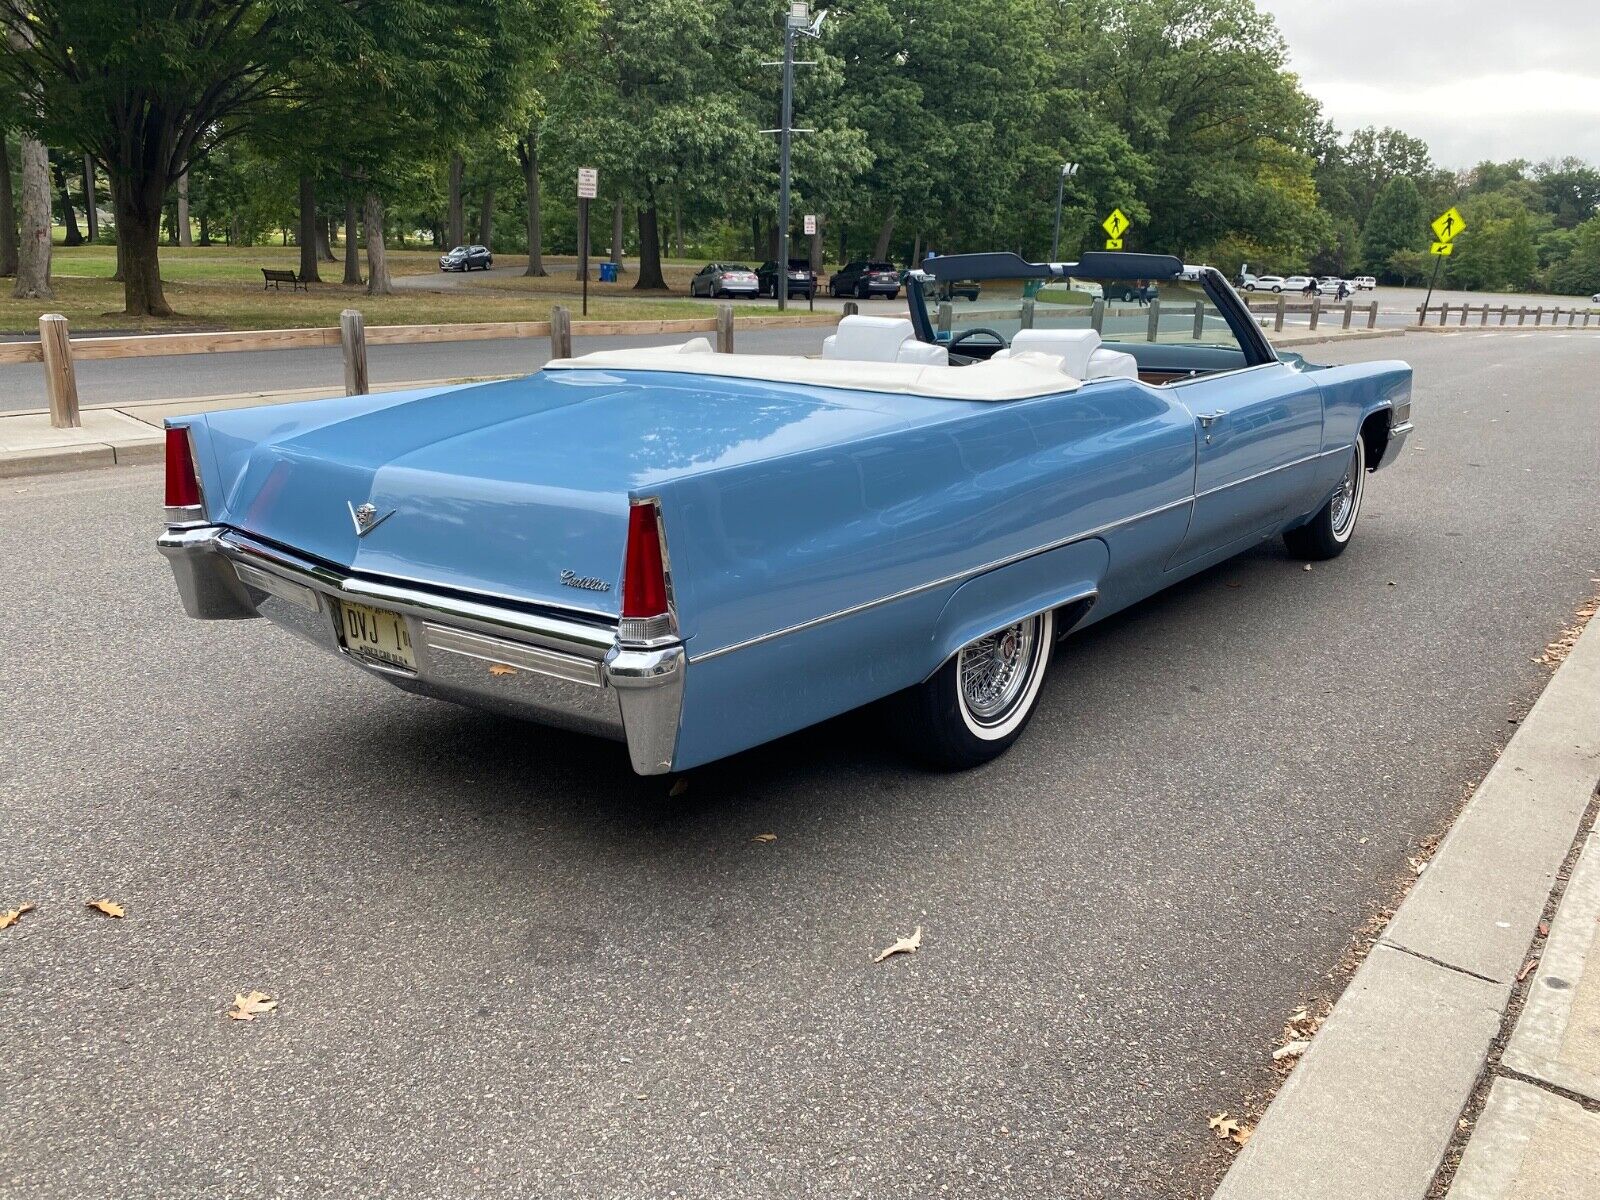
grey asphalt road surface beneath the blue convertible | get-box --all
[0,334,1600,1200]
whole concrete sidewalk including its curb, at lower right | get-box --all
[1214,604,1600,1200]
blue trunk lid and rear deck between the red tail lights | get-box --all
[197,371,936,616]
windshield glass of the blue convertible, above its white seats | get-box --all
[923,278,1245,370]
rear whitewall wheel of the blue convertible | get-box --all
[893,613,1056,771]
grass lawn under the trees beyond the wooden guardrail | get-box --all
[0,245,773,333]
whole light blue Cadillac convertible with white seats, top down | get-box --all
[158,253,1411,774]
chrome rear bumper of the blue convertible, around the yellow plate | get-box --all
[157,525,688,774]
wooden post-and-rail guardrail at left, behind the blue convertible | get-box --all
[0,302,856,429]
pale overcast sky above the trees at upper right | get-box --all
[1256,0,1600,168]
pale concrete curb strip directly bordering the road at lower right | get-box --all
[1214,621,1600,1200]
